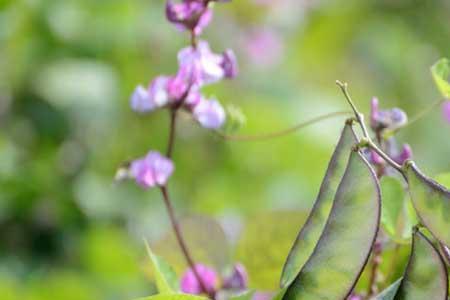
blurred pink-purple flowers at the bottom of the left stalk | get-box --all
[180,263,248,295]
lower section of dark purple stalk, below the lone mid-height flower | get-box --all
[160,186,215,299]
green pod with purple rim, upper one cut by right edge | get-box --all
[405,161,450,245]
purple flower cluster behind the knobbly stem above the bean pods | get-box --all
[367,97,412,176]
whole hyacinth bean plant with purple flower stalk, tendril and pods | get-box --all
[118,0,450,300]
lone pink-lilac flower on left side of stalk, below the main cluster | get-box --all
[130,151,174,188]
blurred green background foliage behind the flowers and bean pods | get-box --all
[0,0,450,300]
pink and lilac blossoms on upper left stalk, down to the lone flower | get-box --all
[127,0,238,188]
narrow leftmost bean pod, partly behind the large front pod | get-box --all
[280,125,356,287]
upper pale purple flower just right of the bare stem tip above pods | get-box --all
[370,97,408,131]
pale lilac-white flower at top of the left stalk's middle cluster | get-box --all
[178,41,225,86]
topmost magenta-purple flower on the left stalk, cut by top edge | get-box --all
[166,0,212,35]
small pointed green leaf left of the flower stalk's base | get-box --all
[145,241,178,294]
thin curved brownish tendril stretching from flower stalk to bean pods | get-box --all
[216,111,351,141]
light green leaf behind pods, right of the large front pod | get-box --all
[380,176,417,243]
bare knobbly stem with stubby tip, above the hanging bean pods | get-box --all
[336,80,405,176]
